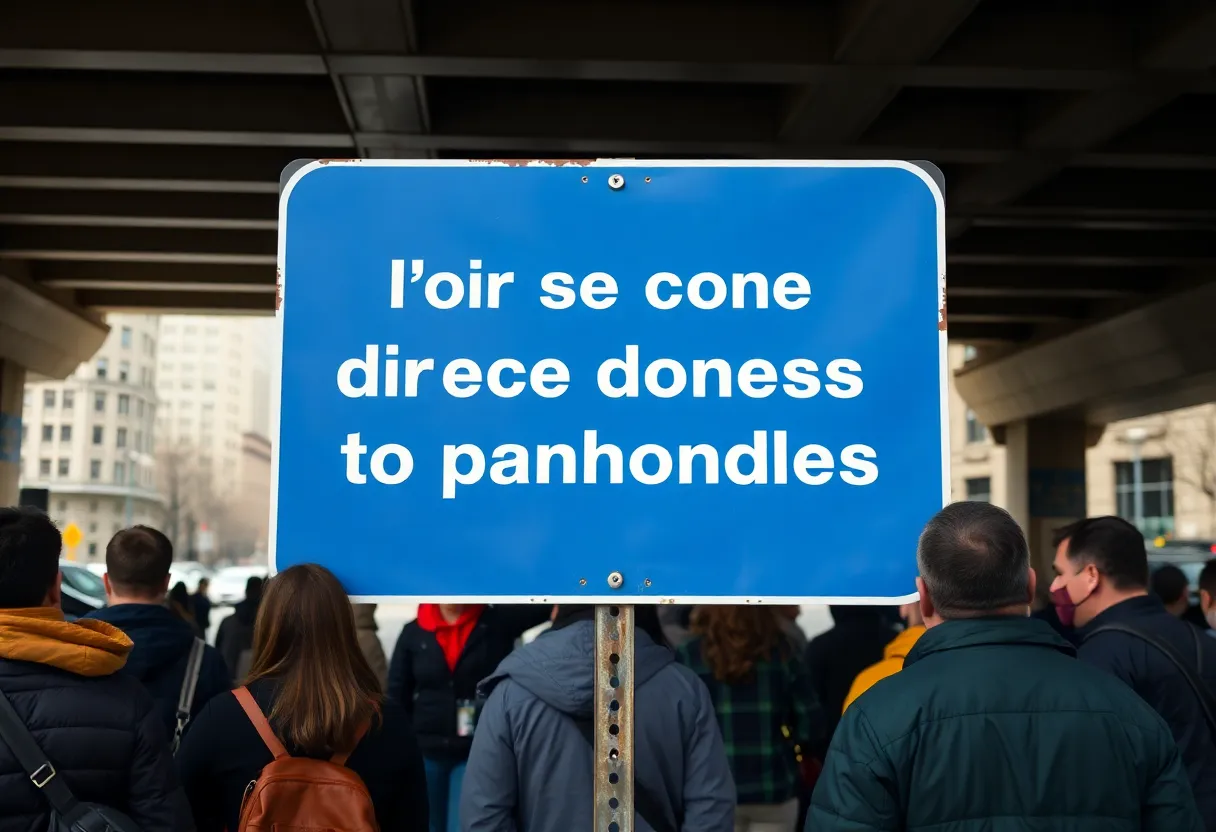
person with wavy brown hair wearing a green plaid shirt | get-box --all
[677,606,822,832]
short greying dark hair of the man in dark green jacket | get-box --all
[917,501,1030,618]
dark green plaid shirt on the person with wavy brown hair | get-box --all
[677,639,822,804]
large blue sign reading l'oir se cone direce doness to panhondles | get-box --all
[271,161,948,602]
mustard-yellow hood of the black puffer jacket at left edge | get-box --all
[0,607,131,676]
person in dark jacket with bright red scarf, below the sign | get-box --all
[388,603,552,832]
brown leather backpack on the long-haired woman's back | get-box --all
[233,687,379,832]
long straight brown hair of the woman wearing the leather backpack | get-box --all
[248,563,383,754]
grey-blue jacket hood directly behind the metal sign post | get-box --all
[478,622,675,718]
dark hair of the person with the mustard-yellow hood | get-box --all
[0,508,63,609]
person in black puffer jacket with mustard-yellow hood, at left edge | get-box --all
[0,508,195,832]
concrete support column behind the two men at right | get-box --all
[998,417,1102,597]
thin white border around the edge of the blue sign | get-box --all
[273,159,951,606]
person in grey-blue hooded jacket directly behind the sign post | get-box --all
[460,605,736,832]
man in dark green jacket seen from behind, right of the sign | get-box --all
[805,502,1204,832]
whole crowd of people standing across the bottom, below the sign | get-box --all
[0,502,1216,832]
